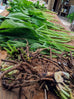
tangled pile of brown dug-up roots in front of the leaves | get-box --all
[0,42,74,99]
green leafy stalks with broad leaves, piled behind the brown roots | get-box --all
[0,0,74,53]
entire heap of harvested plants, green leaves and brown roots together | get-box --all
[0,0,74,99]
